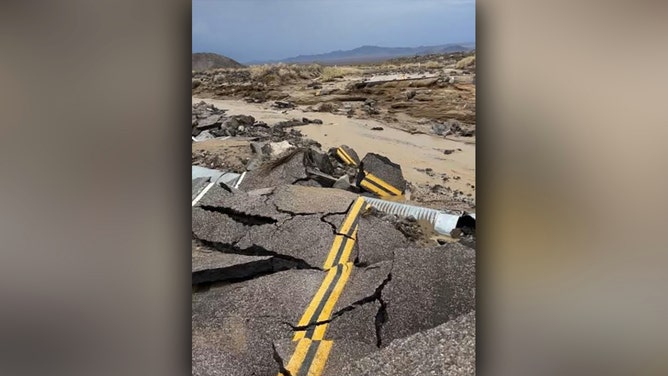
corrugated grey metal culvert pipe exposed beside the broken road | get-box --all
[364,197,475,235]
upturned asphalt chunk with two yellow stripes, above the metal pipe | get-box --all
[357,153,406,197]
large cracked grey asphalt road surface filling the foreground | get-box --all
[191,177,475,376]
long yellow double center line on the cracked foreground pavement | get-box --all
[279,197,369,376]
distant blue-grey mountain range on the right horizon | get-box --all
[247,43,475,64]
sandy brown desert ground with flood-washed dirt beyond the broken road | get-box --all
[192,54,476,211]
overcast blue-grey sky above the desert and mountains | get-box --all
[192,0,475,63]
